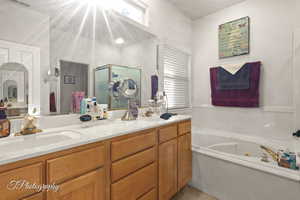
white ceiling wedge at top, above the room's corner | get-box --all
[168,0,245,20]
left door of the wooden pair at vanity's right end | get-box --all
[159,139,177,200]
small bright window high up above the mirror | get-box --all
[114,0,146,25]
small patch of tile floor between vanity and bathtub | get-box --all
[172,186,217,200]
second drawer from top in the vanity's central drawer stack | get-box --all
[111,147,156,182]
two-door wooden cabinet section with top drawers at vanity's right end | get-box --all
[158,120,192,200]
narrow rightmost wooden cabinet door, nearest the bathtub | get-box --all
[178,134,192,190]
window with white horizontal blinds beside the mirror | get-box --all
[163,46,190,109]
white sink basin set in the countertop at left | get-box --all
[0,131,81,155]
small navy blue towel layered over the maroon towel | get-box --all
[217,63,251,90]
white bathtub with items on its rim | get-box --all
[190,129,300,200]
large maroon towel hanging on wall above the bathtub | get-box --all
[210,62,261,107]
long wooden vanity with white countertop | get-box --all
[0,116,192,200]
